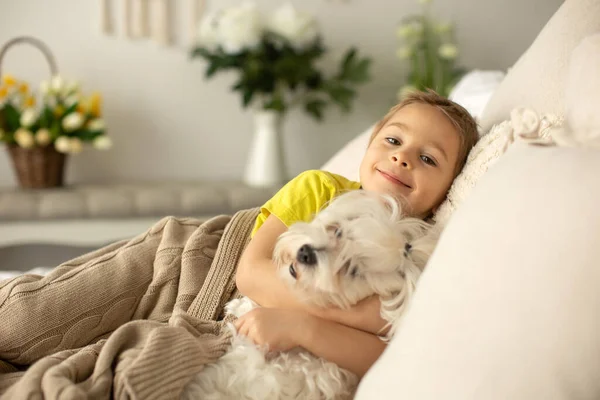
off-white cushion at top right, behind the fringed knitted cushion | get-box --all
[481,0,600,132]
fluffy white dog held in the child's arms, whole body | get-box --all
[183,190,437,400]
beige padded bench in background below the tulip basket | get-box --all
[0,182,278,270]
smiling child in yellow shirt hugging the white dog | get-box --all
[236,91,478,377]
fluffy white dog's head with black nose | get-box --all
[273,190,427,307]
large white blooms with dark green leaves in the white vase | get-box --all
[192,2,370,120]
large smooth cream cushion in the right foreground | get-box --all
[356,144,600,400]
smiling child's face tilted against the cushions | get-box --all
[360,104,460,218]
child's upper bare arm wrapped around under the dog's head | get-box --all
[236,215,386,333]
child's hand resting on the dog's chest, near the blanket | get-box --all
[235,307,314,352]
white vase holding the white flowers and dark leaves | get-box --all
[244,110,286,187]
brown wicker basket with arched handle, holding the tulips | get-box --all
[0,36,66,189]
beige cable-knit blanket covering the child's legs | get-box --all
[0,210,258,399]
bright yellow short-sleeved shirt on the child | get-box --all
[252,170,360,236]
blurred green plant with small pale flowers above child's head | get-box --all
[397,0,466,98]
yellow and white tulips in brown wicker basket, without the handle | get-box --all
[0,75,112,188]
